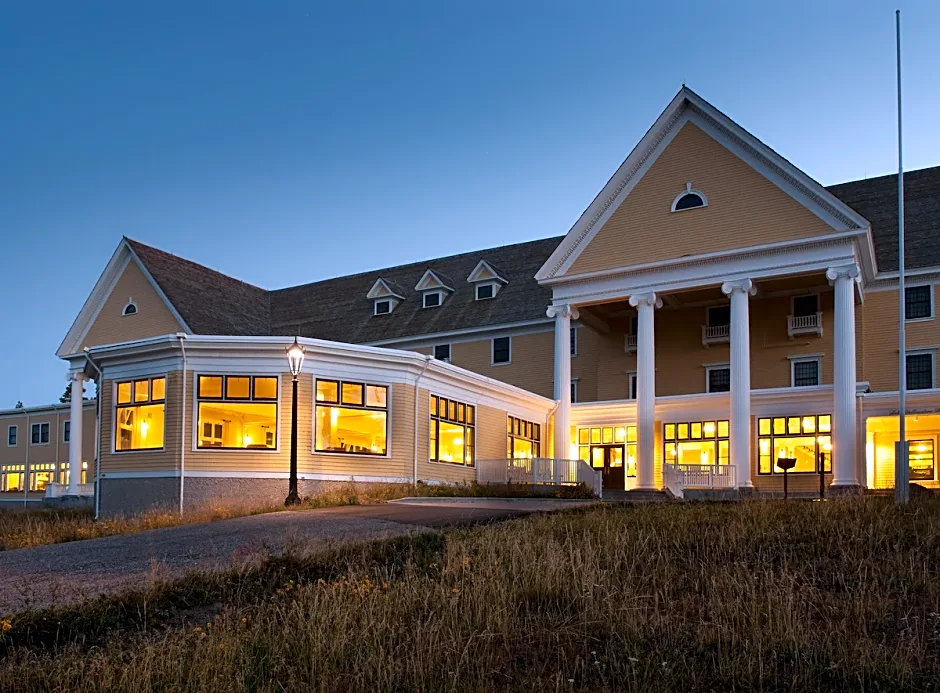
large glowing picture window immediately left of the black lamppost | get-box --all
[196,375,278,450]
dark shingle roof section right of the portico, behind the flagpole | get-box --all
[827,166,940,272]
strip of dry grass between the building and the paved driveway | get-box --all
[0,483,592,551]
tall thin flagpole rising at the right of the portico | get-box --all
[894,10,910,504]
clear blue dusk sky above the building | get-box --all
[0,0,940,408]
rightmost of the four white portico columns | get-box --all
[826,264,859,486]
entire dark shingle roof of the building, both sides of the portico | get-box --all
[128,166,940,343]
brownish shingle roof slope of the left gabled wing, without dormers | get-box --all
[126,238,270,336]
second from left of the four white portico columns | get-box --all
[630,293,663,489]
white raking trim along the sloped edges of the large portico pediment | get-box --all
[536,87,870,281]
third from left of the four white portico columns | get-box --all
[721,279,755,488]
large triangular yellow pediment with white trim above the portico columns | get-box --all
[536,88,870,281]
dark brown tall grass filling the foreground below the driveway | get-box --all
[0,499,940,692]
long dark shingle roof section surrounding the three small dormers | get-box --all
[271,237,561,343]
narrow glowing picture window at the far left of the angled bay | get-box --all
[114,377,166,452]
